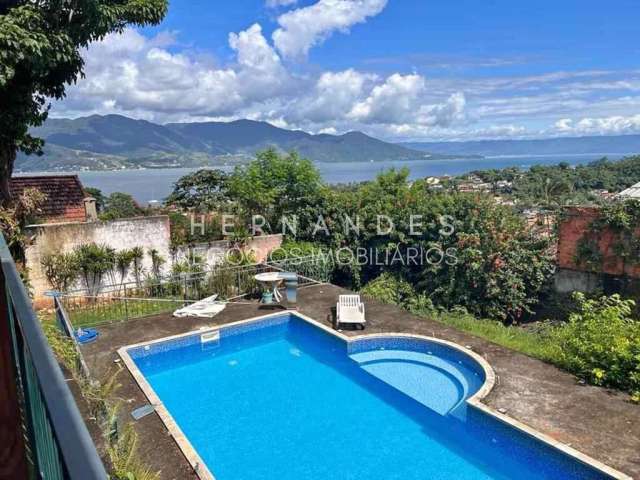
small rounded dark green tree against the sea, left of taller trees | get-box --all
[165,170,229,212]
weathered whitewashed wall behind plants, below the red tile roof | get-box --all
[26,215,171,304]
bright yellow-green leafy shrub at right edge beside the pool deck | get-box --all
[552,294,640,398]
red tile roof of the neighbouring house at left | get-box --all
[9,175,87,223]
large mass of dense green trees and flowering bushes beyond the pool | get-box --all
[168,150,553,322]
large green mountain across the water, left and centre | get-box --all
[16,115,436,171]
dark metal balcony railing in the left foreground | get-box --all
[0,235,107,480]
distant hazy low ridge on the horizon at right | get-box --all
[400,135,640,156]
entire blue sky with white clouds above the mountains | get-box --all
[53,0,640,140]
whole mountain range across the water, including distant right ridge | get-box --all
[16,115,640,171]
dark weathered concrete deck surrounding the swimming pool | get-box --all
[82,285,640,480]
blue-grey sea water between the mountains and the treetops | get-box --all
[17,153,624,204]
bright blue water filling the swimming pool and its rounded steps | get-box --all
[129,314,609,480]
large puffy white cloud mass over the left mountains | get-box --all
[63,24,291,120]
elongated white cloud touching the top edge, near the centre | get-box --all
[273,0,387,58]
